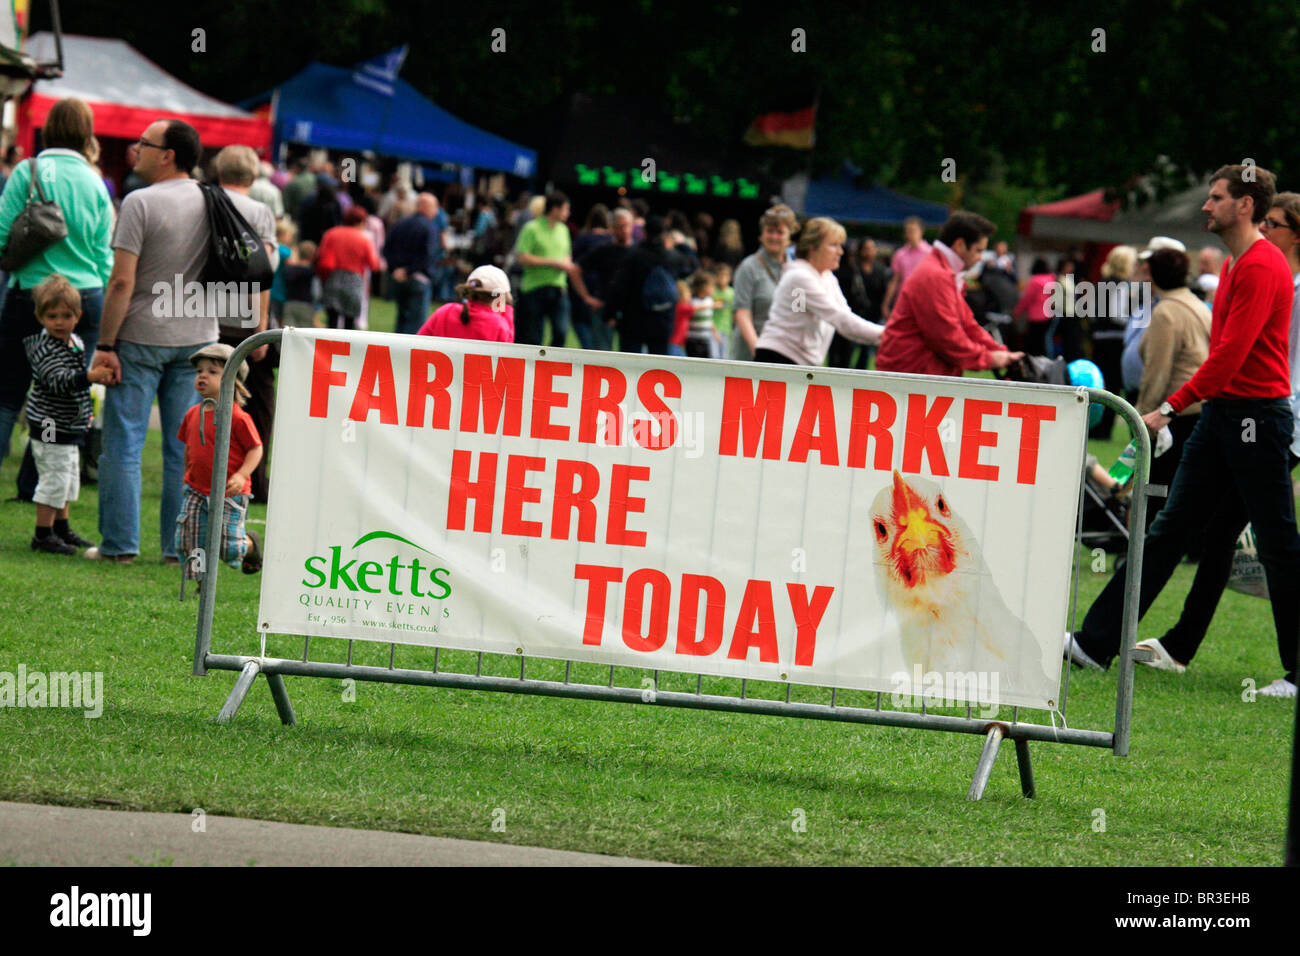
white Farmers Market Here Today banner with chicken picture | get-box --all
[259,329,1087,708]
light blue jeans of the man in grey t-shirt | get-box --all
[99,341,211,557]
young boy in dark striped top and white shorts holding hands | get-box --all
[22,276,112,554]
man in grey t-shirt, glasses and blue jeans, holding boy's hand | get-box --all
[86,120,217,563]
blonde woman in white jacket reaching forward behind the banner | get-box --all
[754,217,885,365]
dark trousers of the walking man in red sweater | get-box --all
[1076,398,1300,682]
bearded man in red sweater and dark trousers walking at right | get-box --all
[1066,165,1300,697]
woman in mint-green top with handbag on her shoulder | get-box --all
[0,98,113,470]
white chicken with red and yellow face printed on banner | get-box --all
[871,471,1052,697]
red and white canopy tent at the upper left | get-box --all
[18,33,272,155]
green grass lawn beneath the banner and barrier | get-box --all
[0,319,1295,865]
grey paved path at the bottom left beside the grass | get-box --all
[0,803,664,866]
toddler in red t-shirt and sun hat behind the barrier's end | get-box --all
[176,345,261,578]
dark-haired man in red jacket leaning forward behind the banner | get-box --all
[876,212,1024,375]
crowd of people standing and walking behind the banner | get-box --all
[0,99,1300,696]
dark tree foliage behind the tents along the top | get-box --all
[34,0,1300,194]
